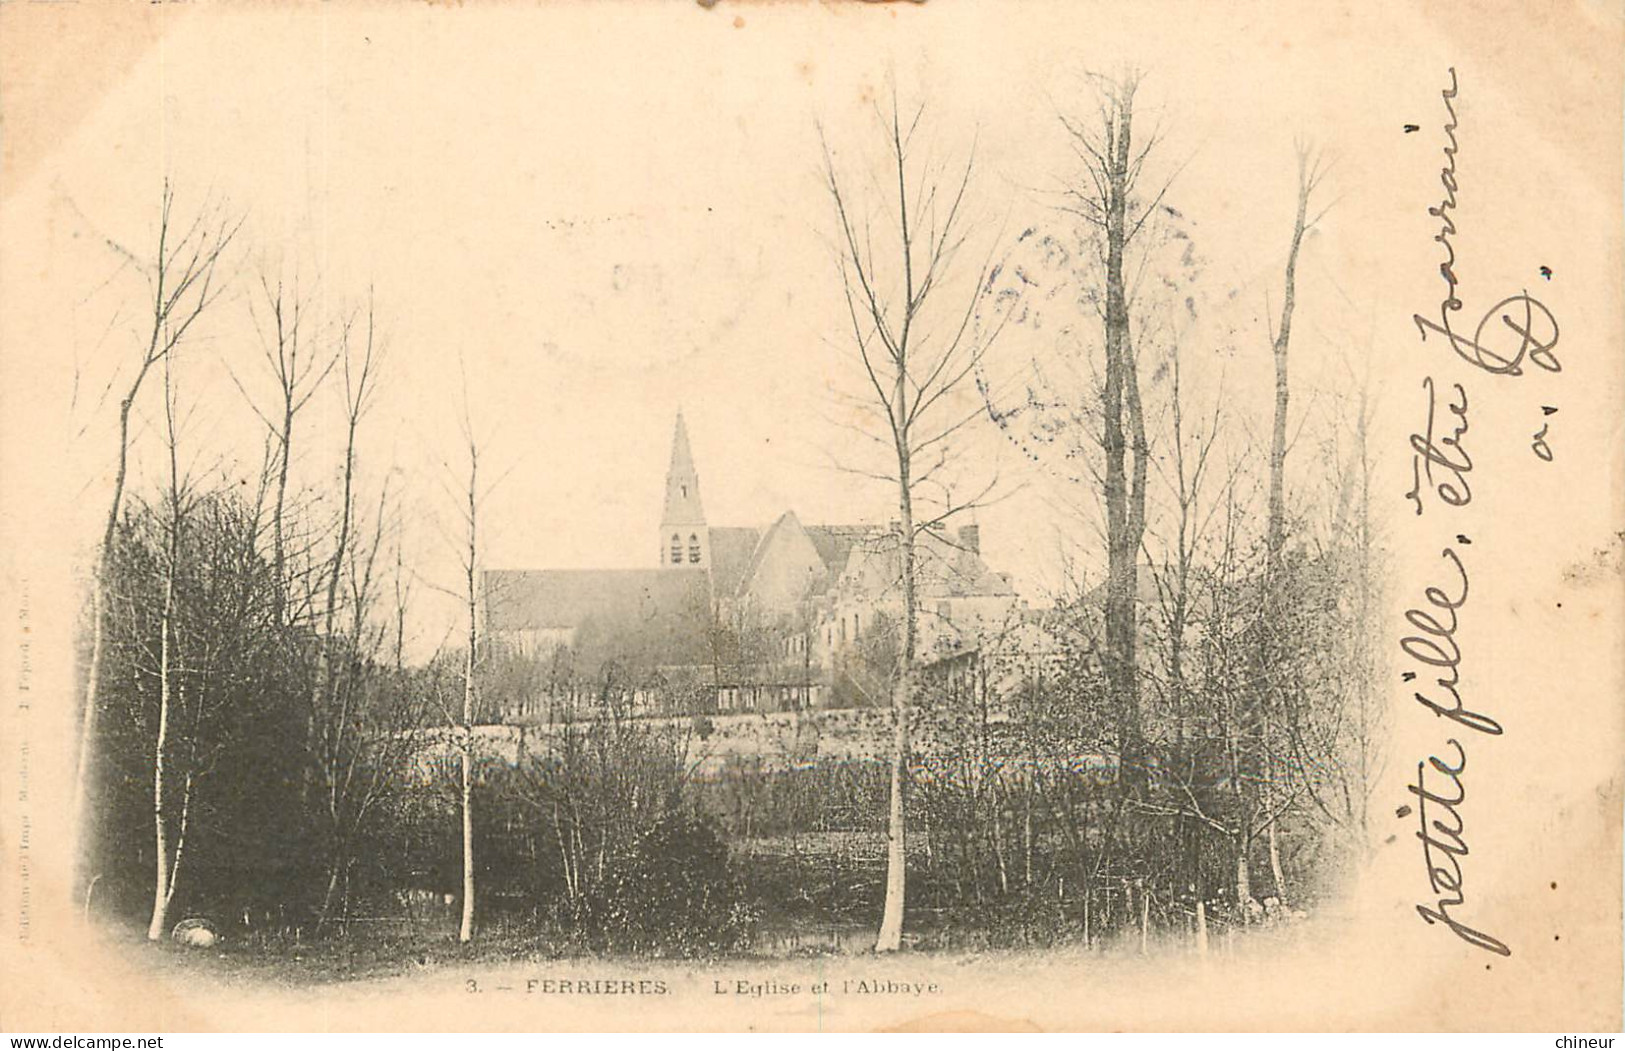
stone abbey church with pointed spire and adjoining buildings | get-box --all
[484,413,1021,715]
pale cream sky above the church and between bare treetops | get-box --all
[8,3,1599,656]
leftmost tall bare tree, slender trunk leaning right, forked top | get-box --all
[68,179,241,895]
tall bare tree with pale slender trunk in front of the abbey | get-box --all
[824,91,1009,952]
